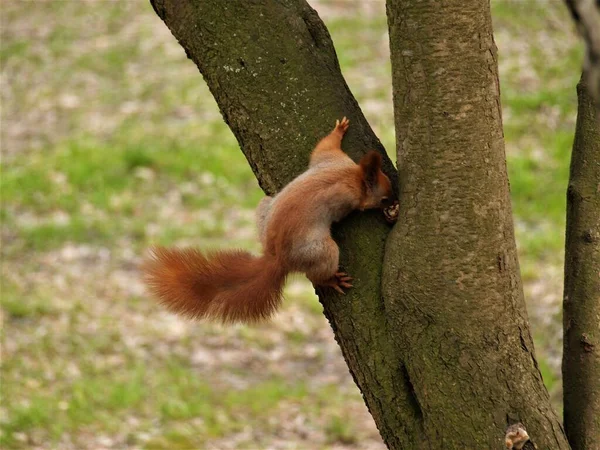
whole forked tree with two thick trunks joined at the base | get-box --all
[151,0,567,449]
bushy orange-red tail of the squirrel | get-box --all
[143,247,287,323]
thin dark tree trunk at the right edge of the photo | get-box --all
[563,75,600,450]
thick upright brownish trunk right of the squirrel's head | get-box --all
[383,0,568,449]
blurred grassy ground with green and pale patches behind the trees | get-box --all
[0,0,582,449]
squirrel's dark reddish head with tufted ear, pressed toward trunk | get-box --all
[358,150,394,211]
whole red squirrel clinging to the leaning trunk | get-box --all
[143,117,393,323]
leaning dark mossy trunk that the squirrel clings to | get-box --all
[151,0,420,448]
